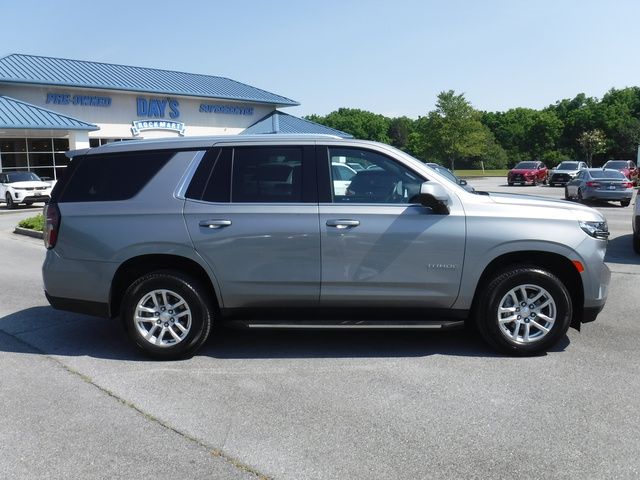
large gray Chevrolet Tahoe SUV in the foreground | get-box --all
[43,135,610,359]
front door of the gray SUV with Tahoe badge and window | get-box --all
[318,146,465,308]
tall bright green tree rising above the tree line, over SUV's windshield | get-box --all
[418,90,490,170]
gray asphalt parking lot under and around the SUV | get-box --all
[0,178,640,480]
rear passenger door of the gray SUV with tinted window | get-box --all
[184,145,321,308]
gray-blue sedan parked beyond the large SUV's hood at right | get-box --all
[564,168,633,207]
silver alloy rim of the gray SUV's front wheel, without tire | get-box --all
[498,284,558,344]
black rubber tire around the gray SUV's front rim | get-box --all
[476,265,573,356]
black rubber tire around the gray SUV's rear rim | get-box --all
[122,270,214,360]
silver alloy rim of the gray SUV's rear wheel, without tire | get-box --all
[134,290,191,347]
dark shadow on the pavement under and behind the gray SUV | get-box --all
[0,306,569,362]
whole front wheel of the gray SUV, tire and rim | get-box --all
[476,266,572,355]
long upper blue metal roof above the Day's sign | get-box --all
[0,54,299,106]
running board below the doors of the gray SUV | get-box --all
[231,320,464,330]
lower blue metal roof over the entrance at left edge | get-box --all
[0,96,98,131]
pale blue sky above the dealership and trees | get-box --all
[0,0,640,118]
